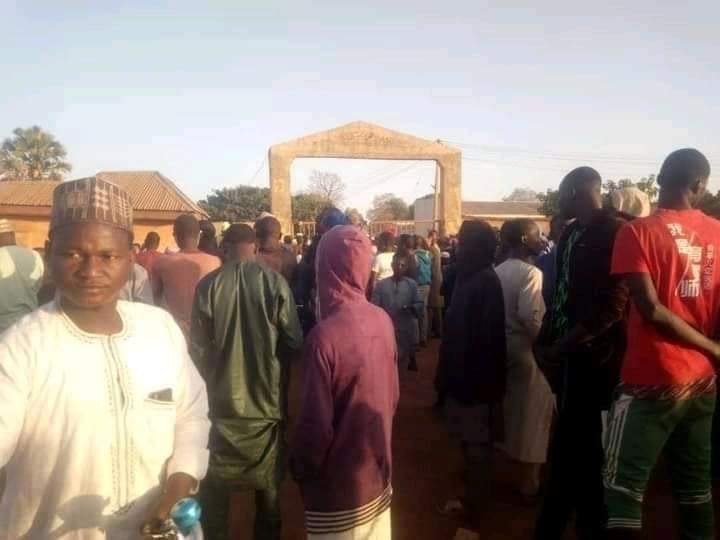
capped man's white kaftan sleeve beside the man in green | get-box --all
[167,315,210,481]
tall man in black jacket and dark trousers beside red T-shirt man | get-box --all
[535,167,629,540]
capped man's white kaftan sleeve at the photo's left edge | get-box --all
[0,330,34,468]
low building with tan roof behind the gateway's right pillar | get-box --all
[414,194,550,234]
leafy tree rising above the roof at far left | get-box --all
[0,126,72,182]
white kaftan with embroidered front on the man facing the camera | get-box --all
[0,301,210,540]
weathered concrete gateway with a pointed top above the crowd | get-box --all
[268,122,462,234]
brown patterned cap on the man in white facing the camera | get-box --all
[50,176,132,231]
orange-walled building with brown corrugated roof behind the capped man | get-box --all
[0,171,207,249]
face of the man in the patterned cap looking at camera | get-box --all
[50,223,133,309]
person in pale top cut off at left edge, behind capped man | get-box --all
[0,219,45,334]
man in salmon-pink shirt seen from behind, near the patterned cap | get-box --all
[150,214,220,336]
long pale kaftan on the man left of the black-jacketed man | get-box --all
[495,259,555,463]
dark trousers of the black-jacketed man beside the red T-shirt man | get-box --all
[535,358,607,540]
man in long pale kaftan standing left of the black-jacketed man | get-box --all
[495,219,555,498]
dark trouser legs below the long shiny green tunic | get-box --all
[199,475,282,540]
